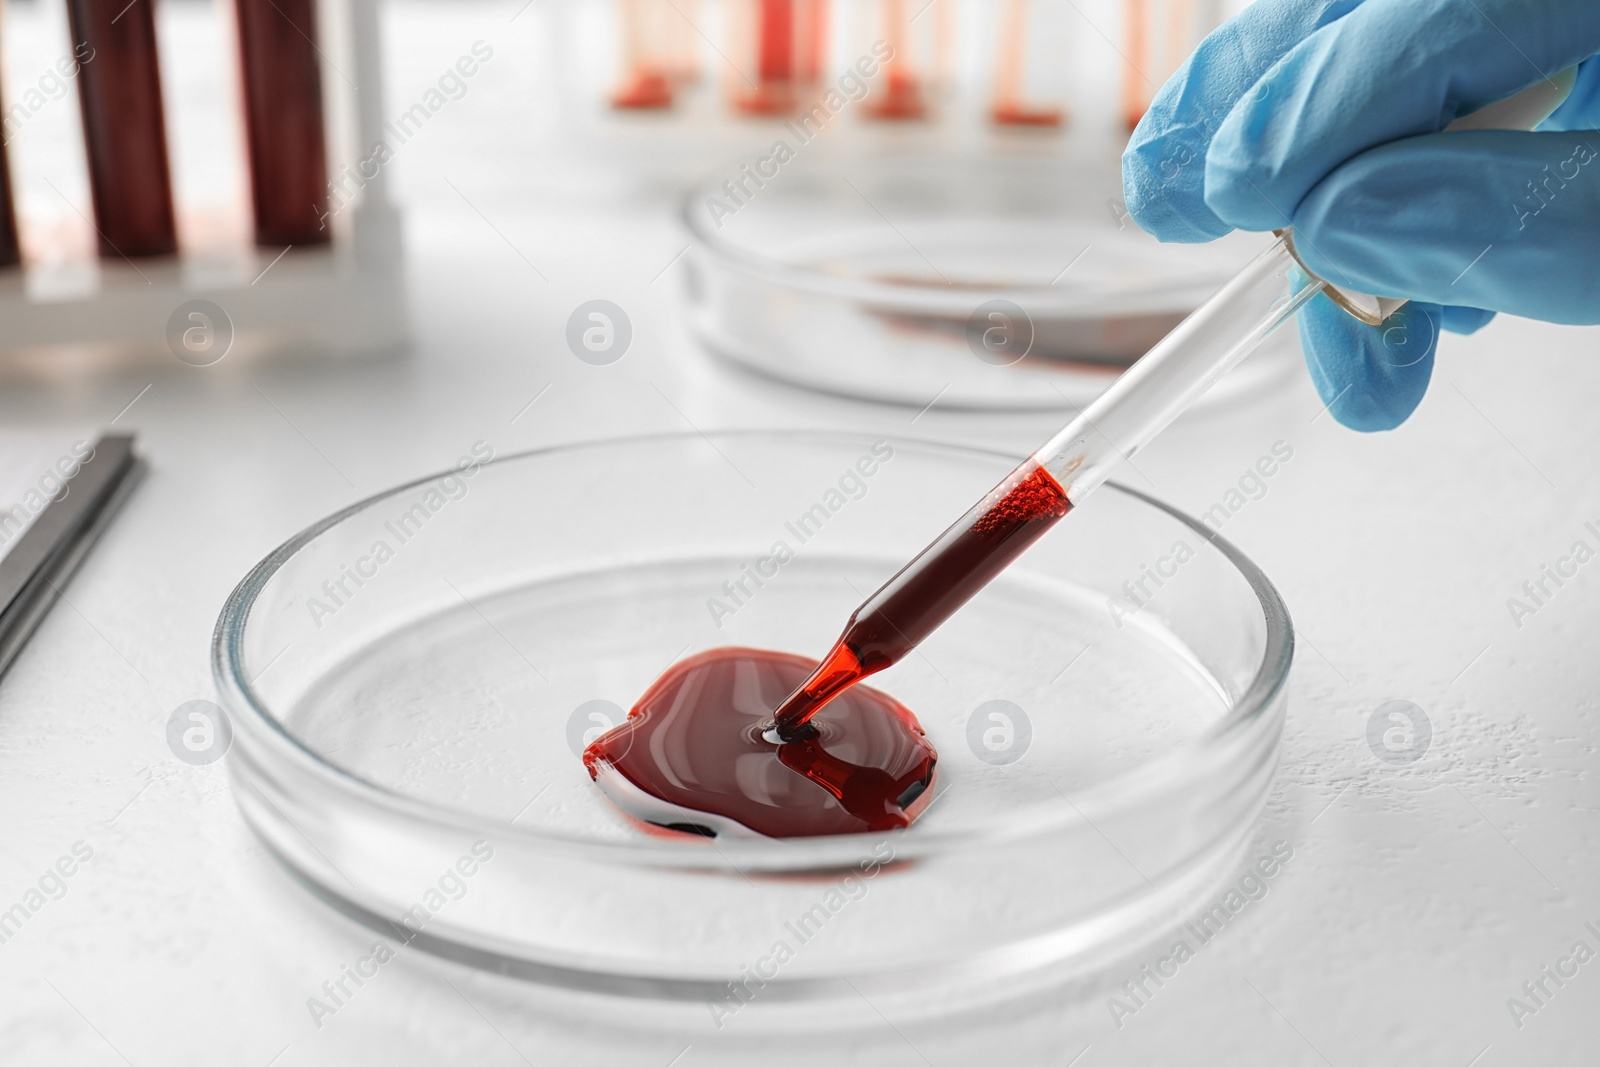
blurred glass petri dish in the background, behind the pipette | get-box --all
[680,155,1293,410]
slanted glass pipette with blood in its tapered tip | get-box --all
[765,70,1576,741]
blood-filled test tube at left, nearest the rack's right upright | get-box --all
[237,0,331,248]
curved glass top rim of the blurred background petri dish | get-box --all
[678,154,1229,317]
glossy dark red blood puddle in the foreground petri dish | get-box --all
[584,648,938,837]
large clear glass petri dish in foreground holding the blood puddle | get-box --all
[213,432,1293,1003]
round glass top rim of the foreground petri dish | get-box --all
[211,429,1294,869]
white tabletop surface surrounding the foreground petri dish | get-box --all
[0,5,1600,1067]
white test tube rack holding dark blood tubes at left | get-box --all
[0,0,408,379]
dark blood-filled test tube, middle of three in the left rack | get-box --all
[67,0,178,258]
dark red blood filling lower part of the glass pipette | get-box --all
[773,462,1072,737]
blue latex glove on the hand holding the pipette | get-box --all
[1123,0,1600,430]
